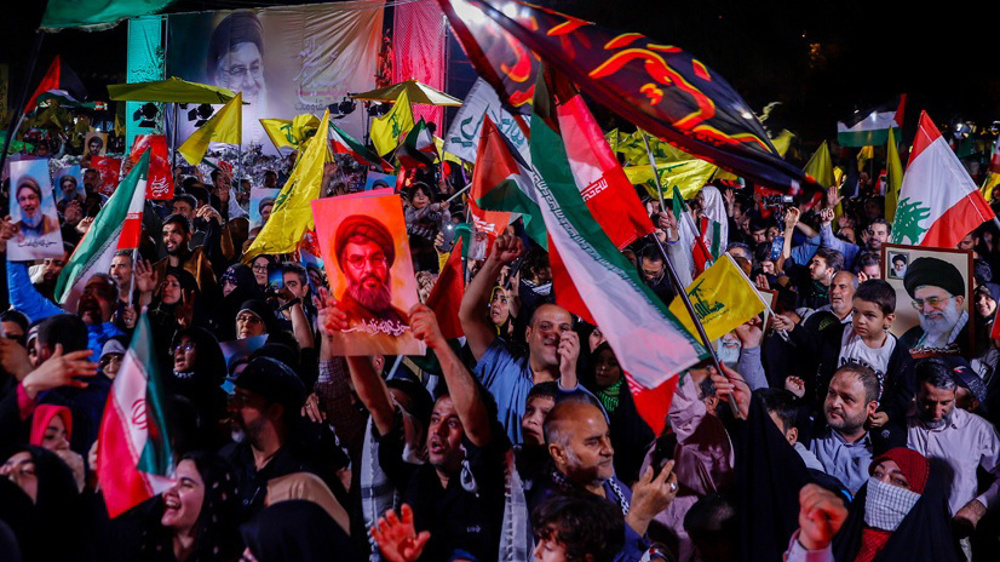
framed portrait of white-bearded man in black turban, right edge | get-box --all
[882,244,975,356]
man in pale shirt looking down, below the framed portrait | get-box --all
[907,359,1000,546]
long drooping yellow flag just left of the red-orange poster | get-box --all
[243,110,330,263]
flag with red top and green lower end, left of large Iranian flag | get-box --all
[471,115,548,248]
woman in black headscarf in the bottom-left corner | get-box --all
[0,445,95,561]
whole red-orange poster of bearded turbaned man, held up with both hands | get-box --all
[312,191,426,355]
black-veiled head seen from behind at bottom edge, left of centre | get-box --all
[240,500,355,562]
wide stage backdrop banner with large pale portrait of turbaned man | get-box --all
[166,0,384,154]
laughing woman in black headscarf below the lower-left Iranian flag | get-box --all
[137,452,239,562]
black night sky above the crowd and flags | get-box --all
[0,0,1000,144]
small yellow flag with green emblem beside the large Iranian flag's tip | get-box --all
[670,254,767,340]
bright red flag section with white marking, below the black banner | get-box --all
[552,75,653,250]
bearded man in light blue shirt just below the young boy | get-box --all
[809,363,879,494]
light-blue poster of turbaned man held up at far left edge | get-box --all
[7,158,63,261]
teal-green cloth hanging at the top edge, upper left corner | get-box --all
[41,0,174,31]
